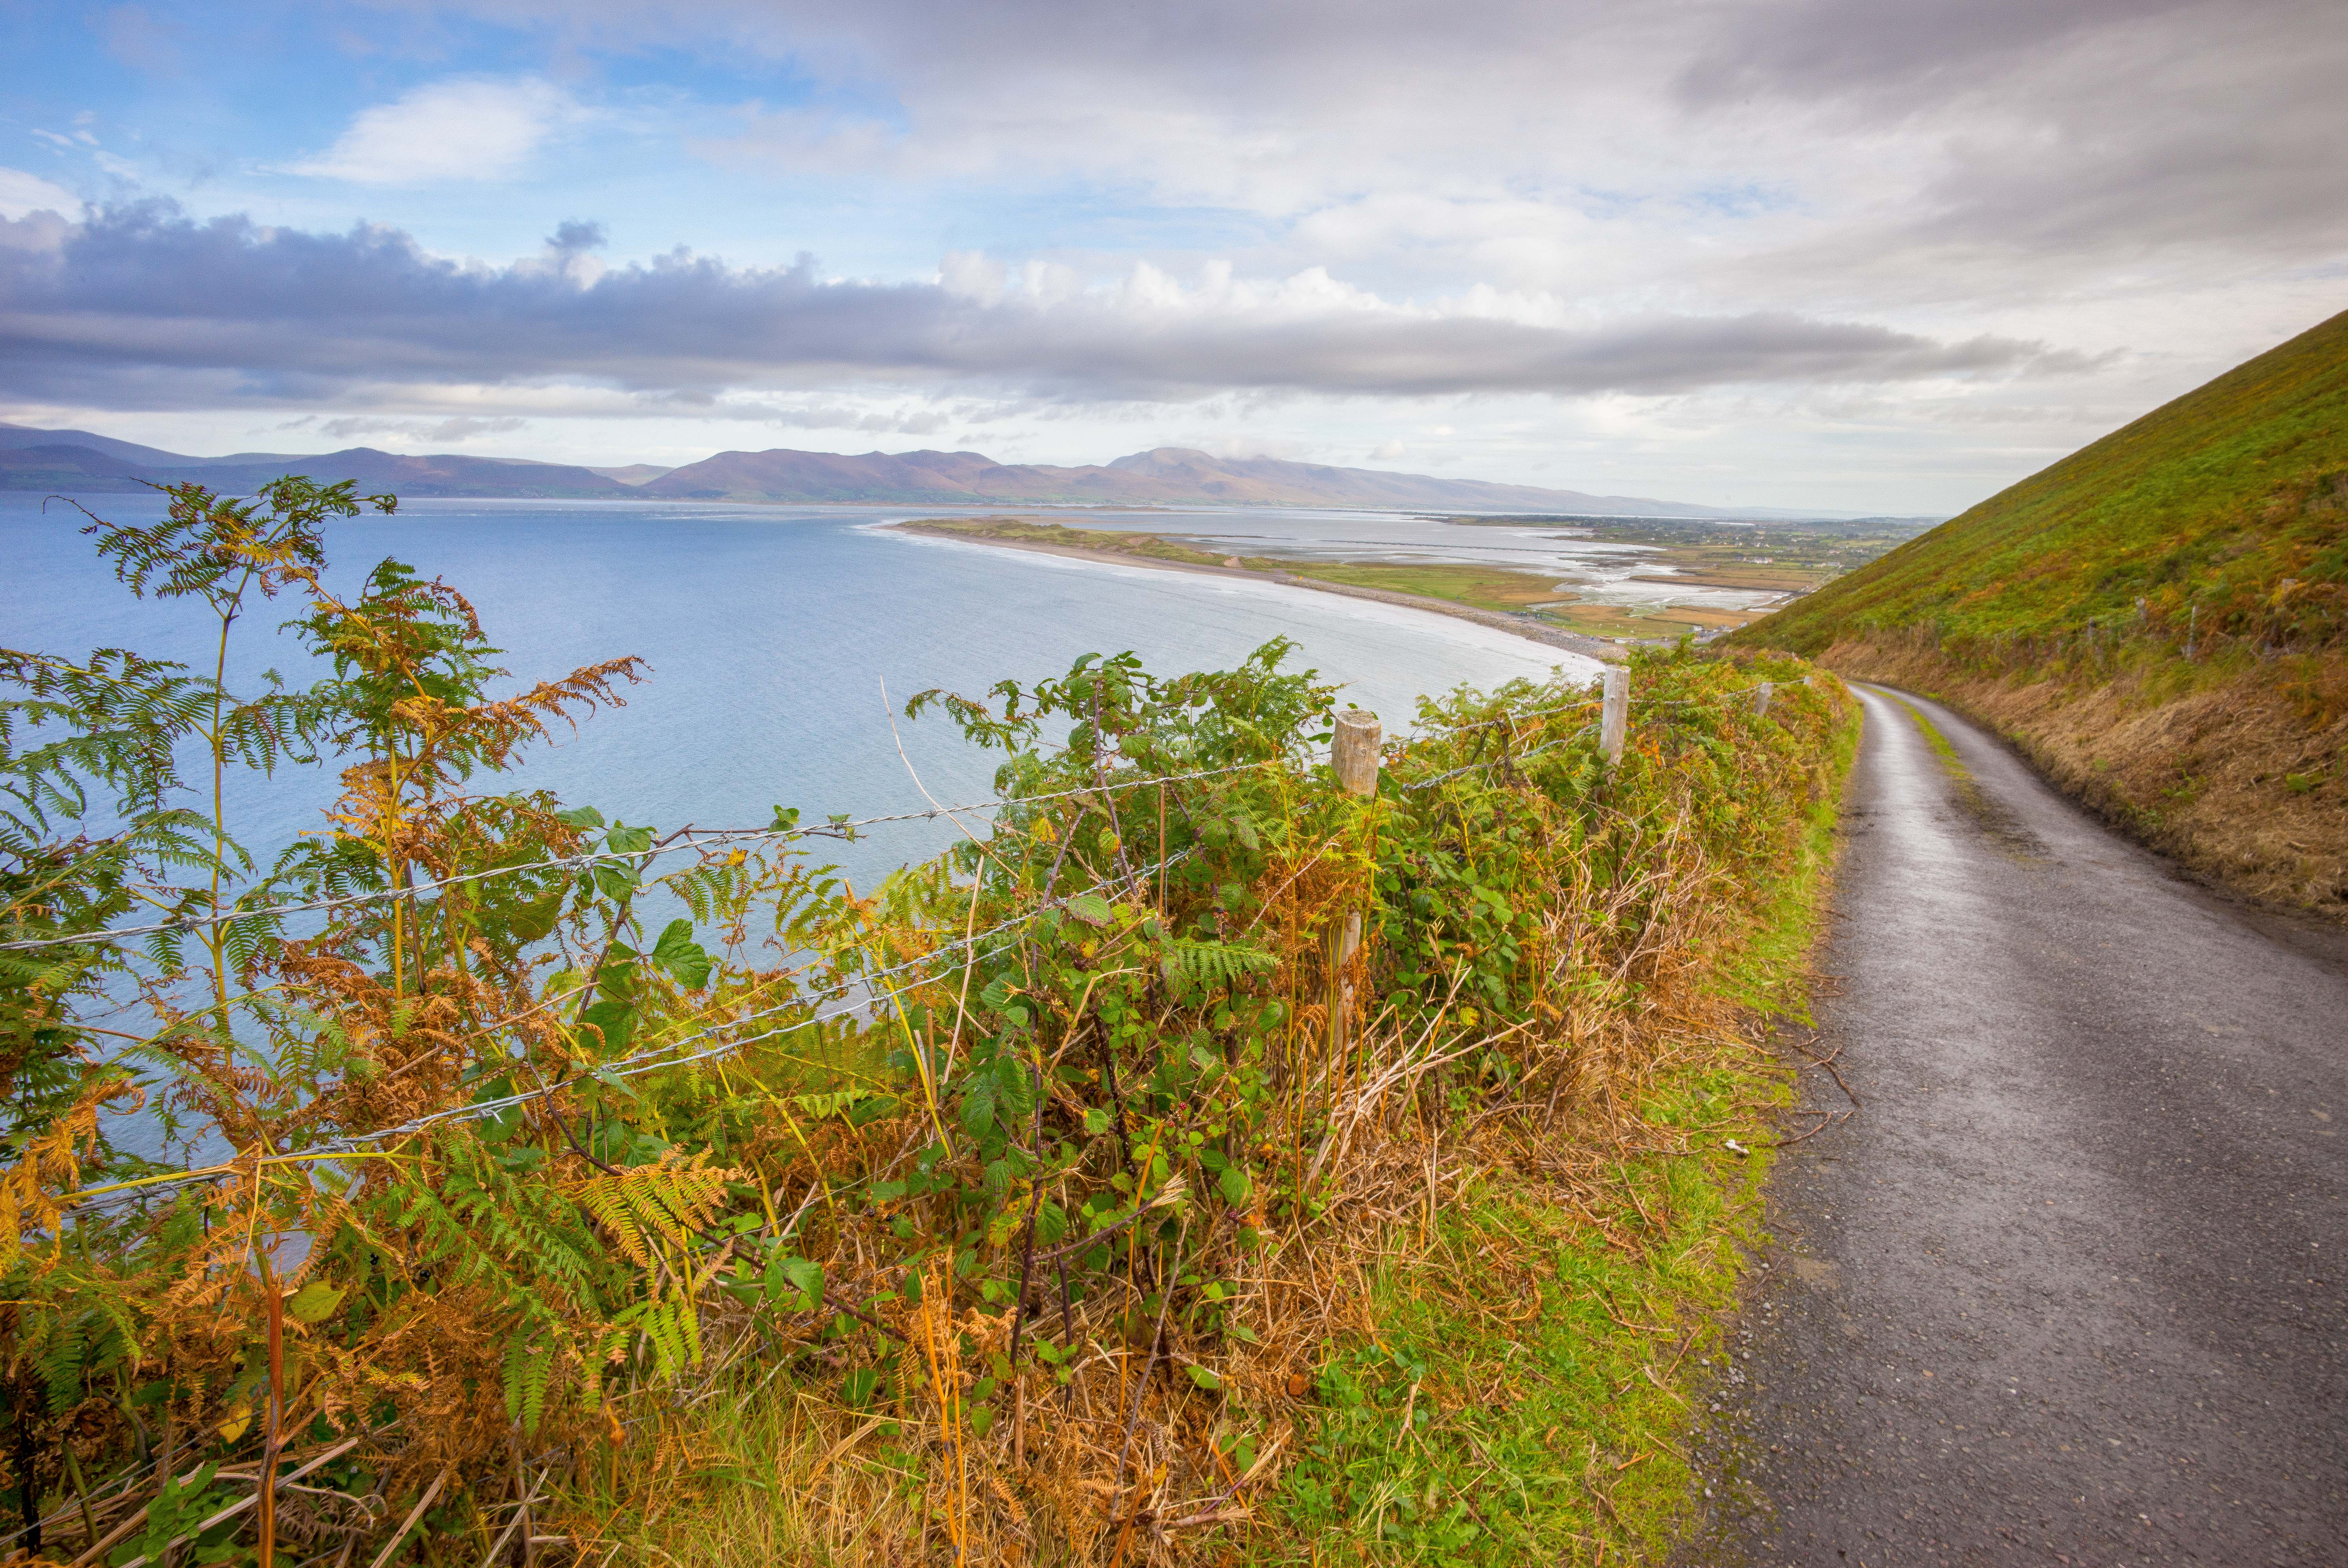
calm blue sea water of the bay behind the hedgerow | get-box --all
[0,495,1597,885]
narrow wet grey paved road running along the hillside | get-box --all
[1688,690,2348,1568]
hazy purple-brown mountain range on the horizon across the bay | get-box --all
[0,425,1820,519]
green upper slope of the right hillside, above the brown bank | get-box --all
[1726,312,2348,655]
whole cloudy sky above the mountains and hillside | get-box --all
[0,0,2348,514]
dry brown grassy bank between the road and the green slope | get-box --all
[1825,636,2348,920]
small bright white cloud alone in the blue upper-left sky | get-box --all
[284,78,587,186]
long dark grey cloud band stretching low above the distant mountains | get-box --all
[0,202,2078,408]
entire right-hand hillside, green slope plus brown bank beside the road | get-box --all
[1728,314,2348,918]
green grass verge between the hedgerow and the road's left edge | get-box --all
[1251,671,1860,1563]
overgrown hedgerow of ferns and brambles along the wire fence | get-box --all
[0,479,1843,1563]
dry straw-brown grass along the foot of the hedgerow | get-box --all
[561,751,1812,1568]
